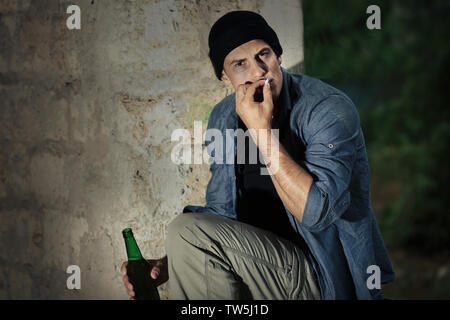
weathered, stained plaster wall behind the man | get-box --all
[0,0,303,299]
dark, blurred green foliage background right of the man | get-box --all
[303,0,450,299]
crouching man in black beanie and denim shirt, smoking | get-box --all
[122,11,394,299]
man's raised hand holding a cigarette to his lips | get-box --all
[236,79,273,134]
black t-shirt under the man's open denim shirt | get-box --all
[236,119,298,240]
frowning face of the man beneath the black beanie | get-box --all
[222,40,283,102]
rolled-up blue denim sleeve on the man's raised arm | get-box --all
[302,95,361,231]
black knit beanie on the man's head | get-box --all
[208,11,283,80]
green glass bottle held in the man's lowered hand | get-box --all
[122,228,160,300]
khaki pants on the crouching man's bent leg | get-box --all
[166,213,320,300]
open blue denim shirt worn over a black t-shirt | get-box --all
[183,68,394,299]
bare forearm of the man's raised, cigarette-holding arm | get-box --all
[253,130,313,222]
